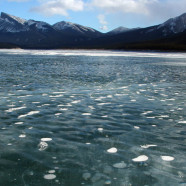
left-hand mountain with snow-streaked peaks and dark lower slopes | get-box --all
[0,13,102,48]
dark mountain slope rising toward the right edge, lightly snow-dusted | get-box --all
[83,13,186,48]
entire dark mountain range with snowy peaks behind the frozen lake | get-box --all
[0,12,186,50]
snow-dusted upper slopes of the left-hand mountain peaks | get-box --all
[0,12,101,37]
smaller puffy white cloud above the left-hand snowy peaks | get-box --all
[31,0,84,16]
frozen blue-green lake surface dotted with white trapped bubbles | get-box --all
[0,50,186,186]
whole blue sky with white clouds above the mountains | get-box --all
[0,0,186,32]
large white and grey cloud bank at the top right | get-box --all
[90,0,186,19]
